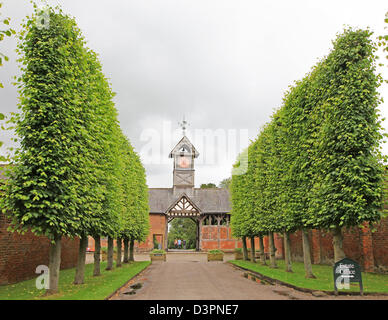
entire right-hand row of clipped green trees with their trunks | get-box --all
[231,28,385,278]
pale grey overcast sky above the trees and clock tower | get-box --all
[0,0,388,187]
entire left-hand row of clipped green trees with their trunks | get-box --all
[1,7,149,293]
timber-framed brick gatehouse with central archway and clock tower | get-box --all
[137,135,237,251]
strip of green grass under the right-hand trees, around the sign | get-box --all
[229,260,388,293]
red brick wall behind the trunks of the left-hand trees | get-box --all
[0,214,79,285]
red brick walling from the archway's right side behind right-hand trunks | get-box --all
[201,222,388,272]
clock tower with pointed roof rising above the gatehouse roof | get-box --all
[169,135,199,193]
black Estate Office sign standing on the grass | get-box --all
[333,258,363,295]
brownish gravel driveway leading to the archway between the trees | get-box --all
[112,253,388,300]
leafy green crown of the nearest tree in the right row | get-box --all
[306,29,384,228]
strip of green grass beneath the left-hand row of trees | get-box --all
[0,261,151,300]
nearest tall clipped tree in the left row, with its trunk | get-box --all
[2,9,90,293]
